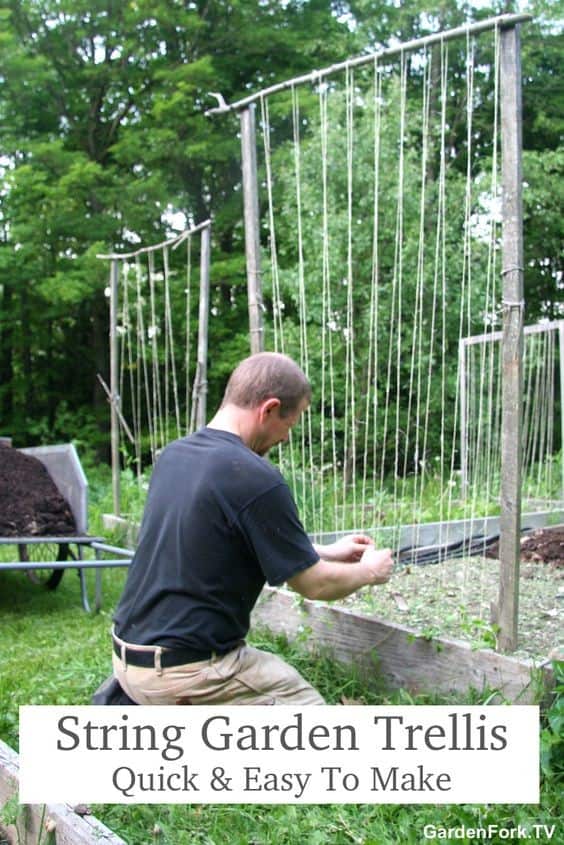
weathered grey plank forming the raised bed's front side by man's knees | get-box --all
[253,588,539,704]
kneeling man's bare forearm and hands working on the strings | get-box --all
[288,546,394,601]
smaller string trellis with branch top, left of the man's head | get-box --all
[98,220,211,516]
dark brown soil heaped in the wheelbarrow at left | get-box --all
[0,446,76,537]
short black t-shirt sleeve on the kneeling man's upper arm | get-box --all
[239,483,319,587]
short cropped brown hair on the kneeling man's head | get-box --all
[222,352,311,417]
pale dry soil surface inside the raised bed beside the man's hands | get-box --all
[342,526,564,659]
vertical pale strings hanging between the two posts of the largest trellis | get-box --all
[260,30,512,543]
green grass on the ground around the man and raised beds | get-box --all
[0,473,564,845]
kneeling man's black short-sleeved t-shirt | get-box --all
[115,428,319,651]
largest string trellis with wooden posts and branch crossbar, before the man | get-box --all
[208,15,562,651]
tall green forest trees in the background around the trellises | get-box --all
[0,0,564,458]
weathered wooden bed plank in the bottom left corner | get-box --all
[0,740,127,845]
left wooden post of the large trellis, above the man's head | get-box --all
[240,103,264,353]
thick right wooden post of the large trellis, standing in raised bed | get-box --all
[497,26,524,651]
